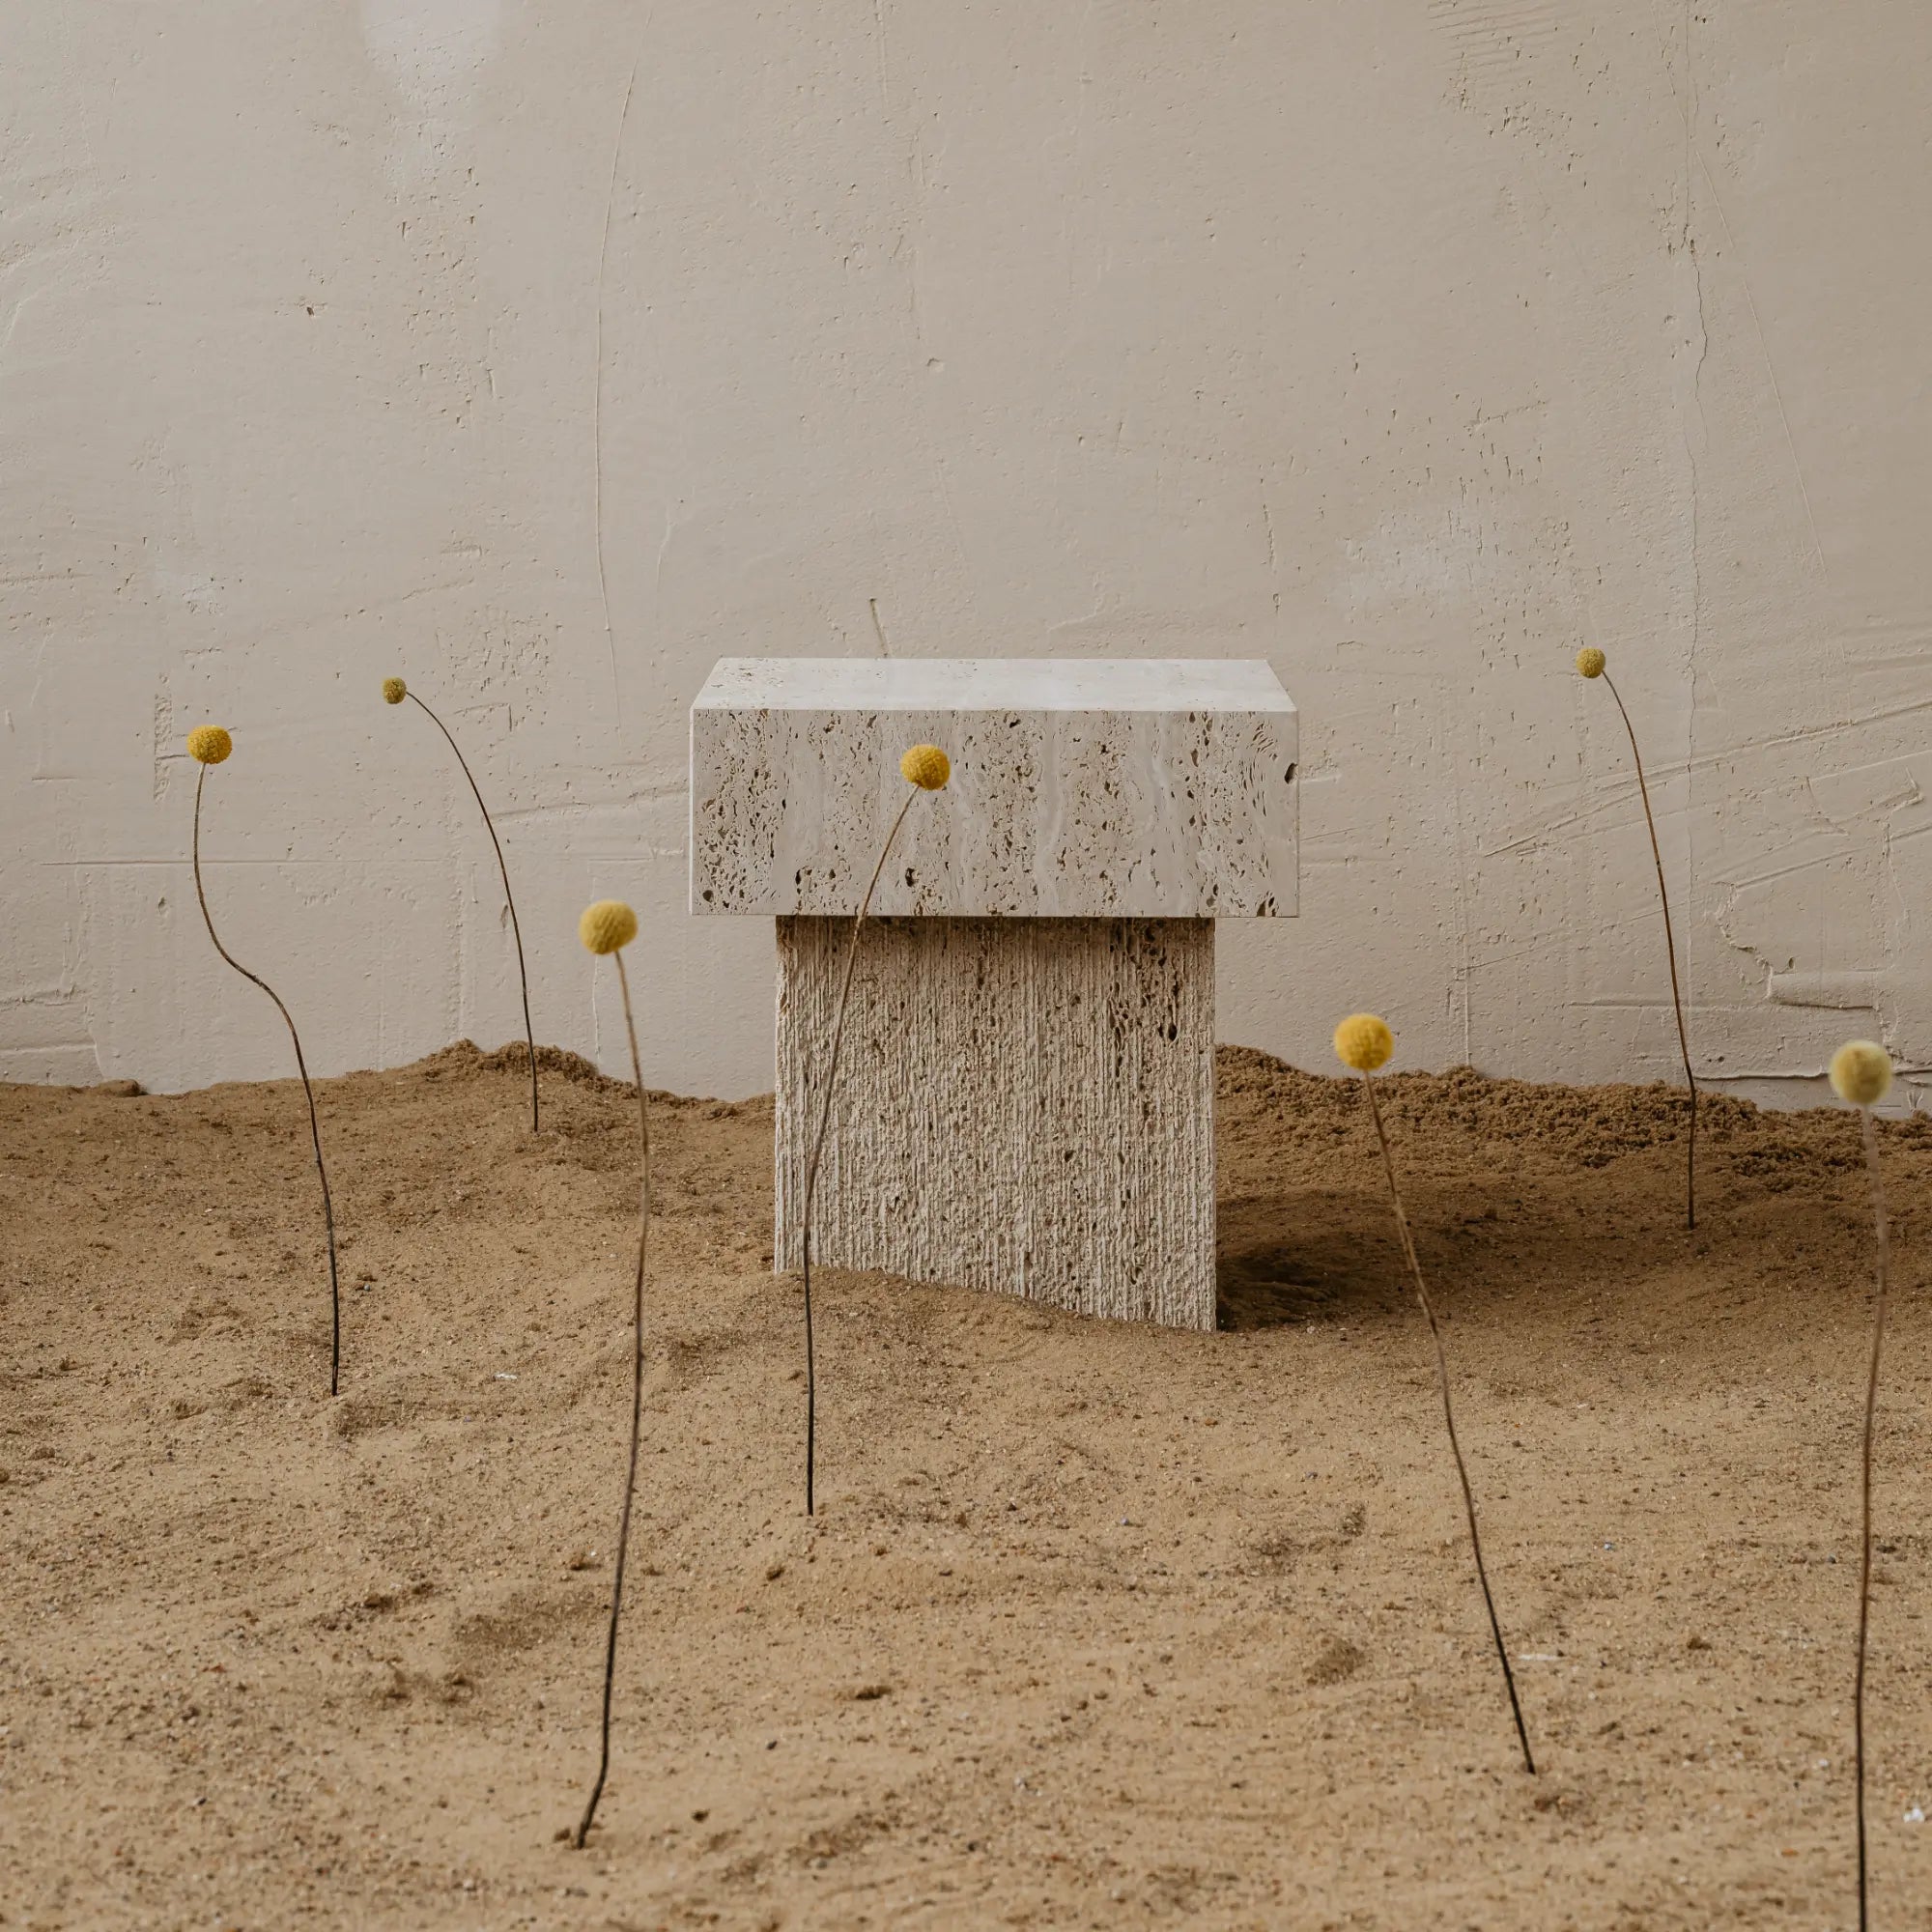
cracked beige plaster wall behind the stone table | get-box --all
[0,0,1932,1094]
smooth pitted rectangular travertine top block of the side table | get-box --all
[692,657,1298,920]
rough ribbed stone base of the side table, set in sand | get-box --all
[773,918,1215,1329]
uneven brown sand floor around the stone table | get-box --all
[0,1045,1932,1932]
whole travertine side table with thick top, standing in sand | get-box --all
[692,657,1296,1329]
